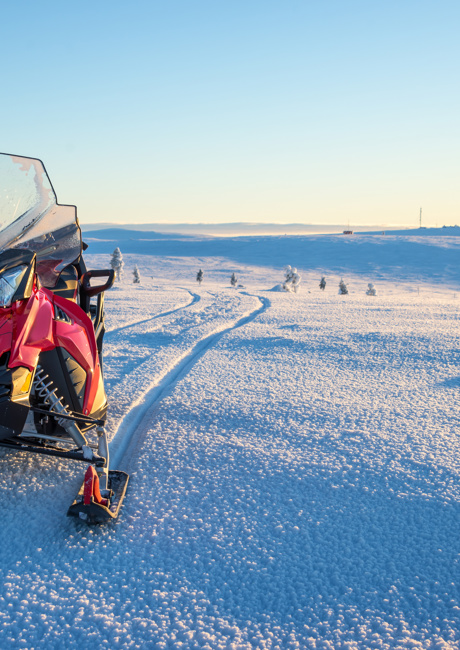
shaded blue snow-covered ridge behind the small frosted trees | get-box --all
[84,228,460,285]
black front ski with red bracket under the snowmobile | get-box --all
[67,465,129,524]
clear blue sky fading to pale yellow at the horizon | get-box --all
[0,0,460,226]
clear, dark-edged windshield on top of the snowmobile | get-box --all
[0,154,81,287]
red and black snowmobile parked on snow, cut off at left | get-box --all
[0,154,129,524]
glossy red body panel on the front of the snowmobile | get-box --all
[0,287,101,414]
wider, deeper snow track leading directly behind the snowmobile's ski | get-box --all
[110,292,271,469]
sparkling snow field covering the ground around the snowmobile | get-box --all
[0,233,460,650]
